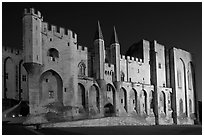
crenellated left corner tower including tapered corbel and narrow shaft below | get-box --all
[23,8,43,115]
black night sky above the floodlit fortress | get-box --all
[2,2,202,100]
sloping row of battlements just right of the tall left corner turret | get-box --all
[42,22,77,39]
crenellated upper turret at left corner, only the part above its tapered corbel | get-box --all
[23,8,43,65]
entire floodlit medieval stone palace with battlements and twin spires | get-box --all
[2,8,196,125]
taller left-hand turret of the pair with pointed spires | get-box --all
[93,21,105,79]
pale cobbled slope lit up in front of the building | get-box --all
[42,117,148,127]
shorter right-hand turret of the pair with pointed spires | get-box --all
[110,27,120,81]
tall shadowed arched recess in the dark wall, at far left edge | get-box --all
[2,57,17,99]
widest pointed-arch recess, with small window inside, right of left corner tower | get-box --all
[40,70,63,104]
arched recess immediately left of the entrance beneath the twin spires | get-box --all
[89,85,100,110]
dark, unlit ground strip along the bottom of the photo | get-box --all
[2,124,202,135]
